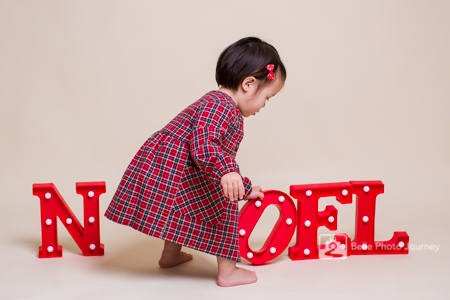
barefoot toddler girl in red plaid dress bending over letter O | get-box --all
[105,37,286,286]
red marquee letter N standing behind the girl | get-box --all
[33,182,106,258]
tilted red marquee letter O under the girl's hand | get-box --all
[238,190,296,265]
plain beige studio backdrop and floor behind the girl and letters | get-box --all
[0,0,450,299]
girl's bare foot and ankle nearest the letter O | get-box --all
[217,257,258,287]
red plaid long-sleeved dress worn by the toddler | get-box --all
[105,91,251,261]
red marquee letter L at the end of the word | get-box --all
[350,181,409,255]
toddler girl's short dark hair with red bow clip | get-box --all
[216,37,286,91]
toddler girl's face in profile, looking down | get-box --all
[236,74,284,117]
